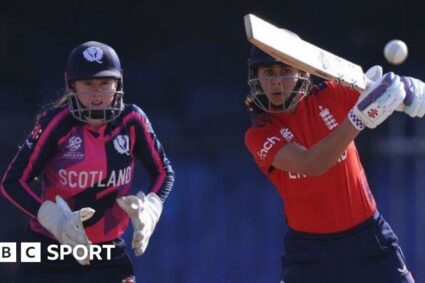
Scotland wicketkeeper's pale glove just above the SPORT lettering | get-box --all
[37,196,95,265]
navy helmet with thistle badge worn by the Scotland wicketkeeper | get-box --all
[65,41,124,122]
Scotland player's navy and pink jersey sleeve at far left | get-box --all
[1,110,66,218]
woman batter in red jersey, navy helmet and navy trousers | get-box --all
[245,47,425,283]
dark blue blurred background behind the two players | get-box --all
[0,0,425,283]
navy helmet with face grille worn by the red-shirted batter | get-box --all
[248,46,310,113]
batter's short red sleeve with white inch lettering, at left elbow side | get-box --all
[245,127,288,171]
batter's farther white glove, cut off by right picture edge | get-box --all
[401,77,425,118]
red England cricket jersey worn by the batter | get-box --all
[245,82,376,234]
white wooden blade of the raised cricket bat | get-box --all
[244,14,367,90]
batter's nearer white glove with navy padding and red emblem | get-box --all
[348,72,406,130]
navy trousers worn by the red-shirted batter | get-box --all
[281,212,415,283]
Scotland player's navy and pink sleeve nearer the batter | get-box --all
[133,105,174,201]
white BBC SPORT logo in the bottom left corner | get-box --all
[0,242,115,263]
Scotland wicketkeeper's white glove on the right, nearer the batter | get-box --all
[117,191,162,256]
